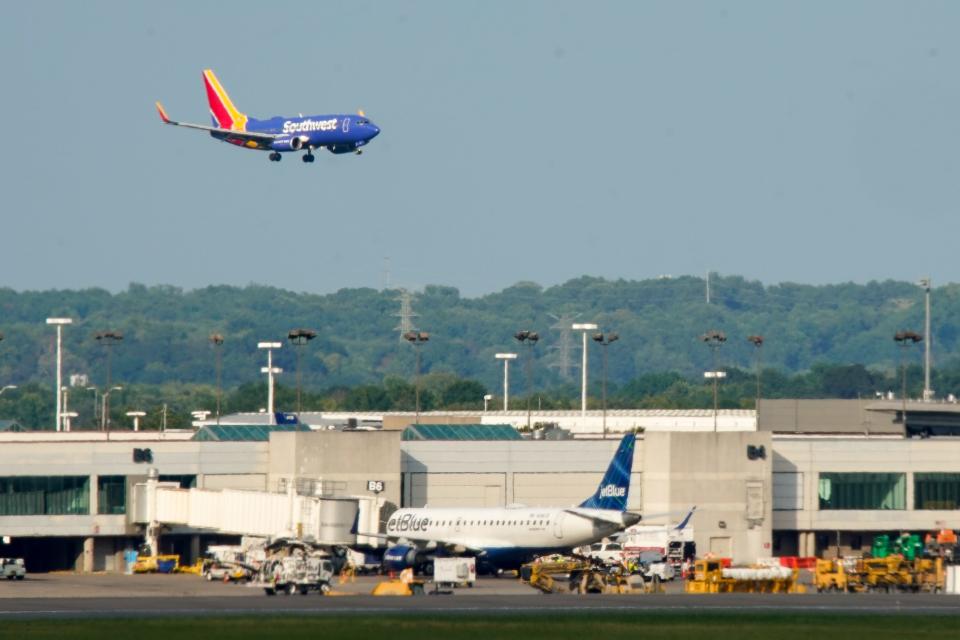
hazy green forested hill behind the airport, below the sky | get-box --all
[0,277,960,389]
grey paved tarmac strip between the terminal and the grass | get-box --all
[0,573,960,619]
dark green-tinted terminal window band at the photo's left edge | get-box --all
[0,476,90,516]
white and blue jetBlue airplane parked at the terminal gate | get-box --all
[377,433,640,571]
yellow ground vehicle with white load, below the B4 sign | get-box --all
[684,559,806,593]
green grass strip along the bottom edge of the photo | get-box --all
[0,612,960,640]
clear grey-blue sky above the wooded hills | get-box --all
[0,0,960,296]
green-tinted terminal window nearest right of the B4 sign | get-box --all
[818,473,907,510]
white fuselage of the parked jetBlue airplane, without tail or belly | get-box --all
[386,507,623,549]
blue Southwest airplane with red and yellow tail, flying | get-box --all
[157,69,380,162]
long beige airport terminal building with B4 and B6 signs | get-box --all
[0,400,960,571]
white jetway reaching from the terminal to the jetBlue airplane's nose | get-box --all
[129,469,382,549]
